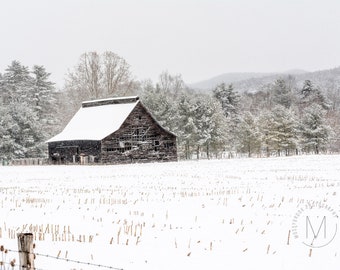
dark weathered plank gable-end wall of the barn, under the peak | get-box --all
[101,103,177,163]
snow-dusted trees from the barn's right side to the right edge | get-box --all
[142,73,340,158]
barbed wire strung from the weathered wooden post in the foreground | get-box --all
[0,249,124,270]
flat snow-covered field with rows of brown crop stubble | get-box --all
[0,156,340,270]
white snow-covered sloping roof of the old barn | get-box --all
[47,96,139,142]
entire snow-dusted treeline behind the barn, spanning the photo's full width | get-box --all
[0,52,340,160]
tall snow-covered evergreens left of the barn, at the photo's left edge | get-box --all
[0,61,55,159]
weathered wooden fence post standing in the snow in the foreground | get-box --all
[18,233,34,270]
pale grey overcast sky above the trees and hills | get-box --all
[0,0,340,87]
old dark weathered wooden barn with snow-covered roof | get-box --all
[47,96,177,164]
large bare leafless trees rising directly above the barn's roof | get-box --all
[64,51,136,115]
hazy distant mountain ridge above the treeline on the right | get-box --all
[189,67,340,93]
